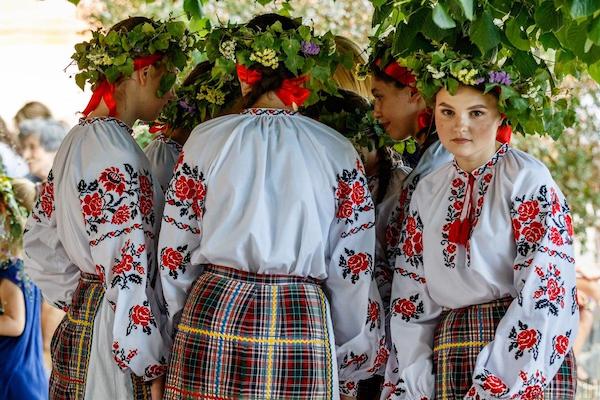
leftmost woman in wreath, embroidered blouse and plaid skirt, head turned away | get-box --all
[25,17,194,399]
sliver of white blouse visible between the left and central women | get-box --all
[144,133,183,193]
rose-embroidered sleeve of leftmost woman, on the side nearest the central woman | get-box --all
[77,164,166,380]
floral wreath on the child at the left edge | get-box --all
[0,172,28,261]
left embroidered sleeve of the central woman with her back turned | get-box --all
[158,152,206,346]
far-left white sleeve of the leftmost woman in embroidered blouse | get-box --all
[23,171,80,311]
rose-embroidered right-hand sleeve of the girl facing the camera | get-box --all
[466,183,579,399]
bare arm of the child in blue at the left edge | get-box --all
[0,279,25,337]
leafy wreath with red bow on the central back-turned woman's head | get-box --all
[201,21,339,106]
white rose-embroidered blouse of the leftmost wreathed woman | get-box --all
[24,118,166,384]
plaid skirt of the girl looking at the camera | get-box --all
[433,297,577,400]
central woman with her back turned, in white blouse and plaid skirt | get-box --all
[159,14,383,399]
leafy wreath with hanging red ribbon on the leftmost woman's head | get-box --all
[71,19,197,116]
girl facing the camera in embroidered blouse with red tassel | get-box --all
[383,79,578,400]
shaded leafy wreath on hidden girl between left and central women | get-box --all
[158,64,241,129]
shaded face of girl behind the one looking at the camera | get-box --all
[371,77,415,140]
